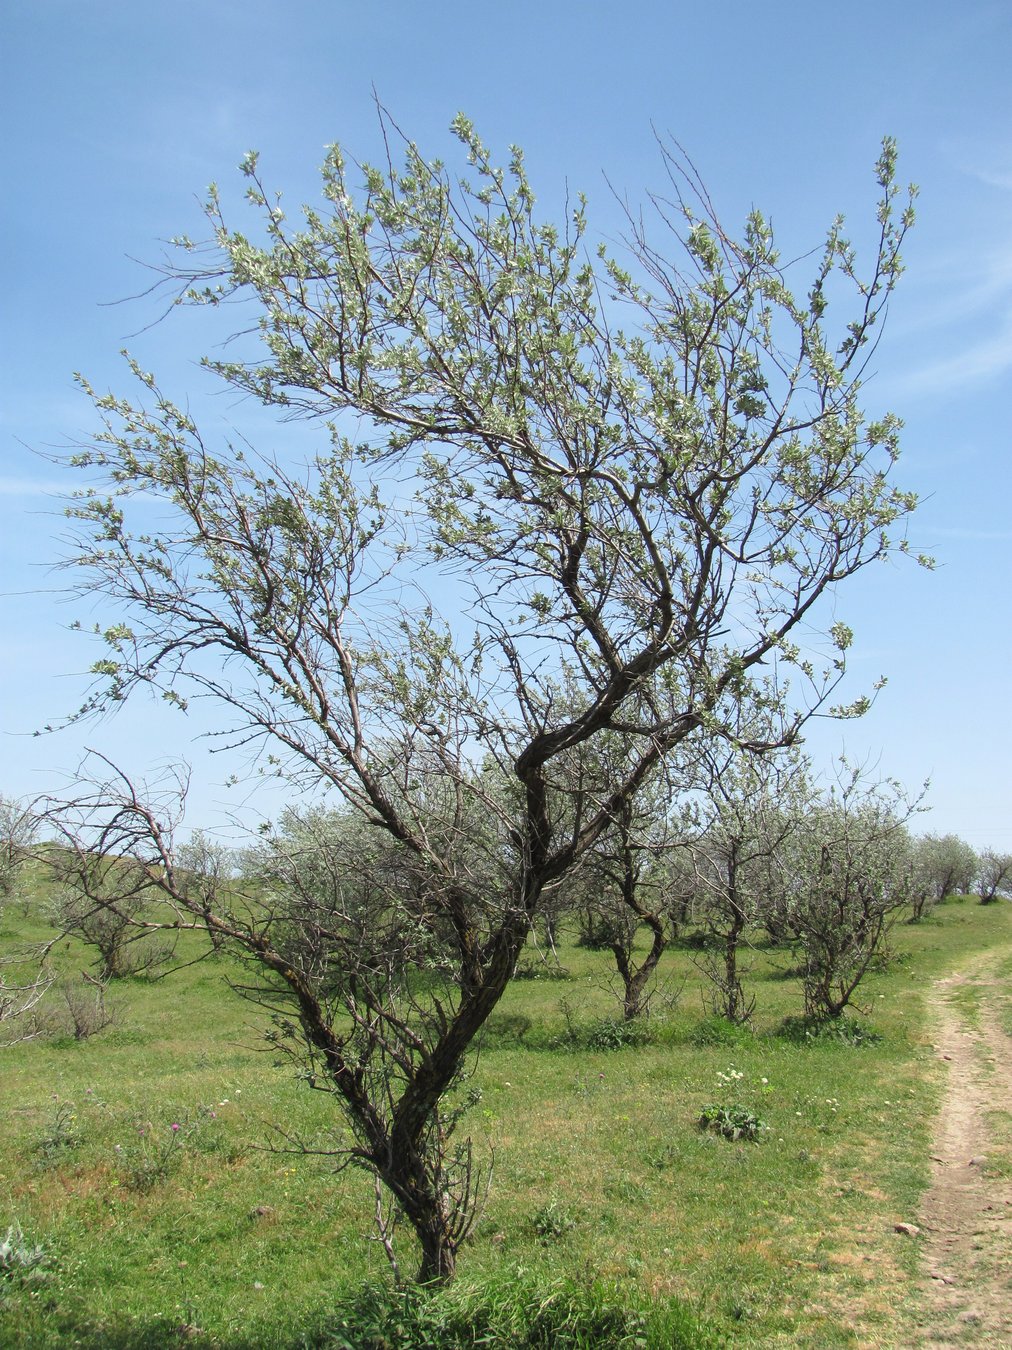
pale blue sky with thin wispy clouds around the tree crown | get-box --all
[0,0,1012,849]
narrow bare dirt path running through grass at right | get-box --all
[915,954,1012,1350]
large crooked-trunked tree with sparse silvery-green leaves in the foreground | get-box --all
[59,117,913,1280]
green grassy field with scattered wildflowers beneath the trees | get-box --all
[0,900,1012,1350]
